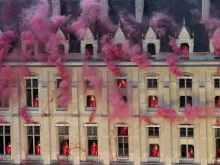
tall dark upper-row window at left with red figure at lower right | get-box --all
[26,77,38,107]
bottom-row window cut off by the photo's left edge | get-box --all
[0,126,11,155]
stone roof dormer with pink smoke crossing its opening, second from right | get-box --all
[176,19,194,53]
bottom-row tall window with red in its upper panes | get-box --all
[118,127,129,156]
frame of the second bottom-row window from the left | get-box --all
[26,124,41,155]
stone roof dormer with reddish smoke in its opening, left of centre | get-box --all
[81,24,98,59]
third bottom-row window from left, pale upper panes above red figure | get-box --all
[58,126,69,155]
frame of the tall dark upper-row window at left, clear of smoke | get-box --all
[24,76,39,109]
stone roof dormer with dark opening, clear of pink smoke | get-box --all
[142,21,160,55]
